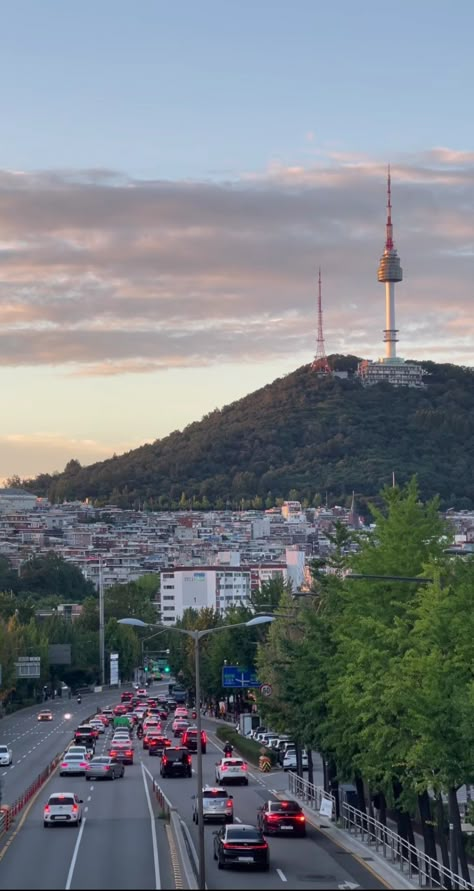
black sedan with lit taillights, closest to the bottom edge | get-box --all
[214,823,270,872]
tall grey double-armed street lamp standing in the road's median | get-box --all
[118,616,274,891]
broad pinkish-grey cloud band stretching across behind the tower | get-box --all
[0,154,474,377]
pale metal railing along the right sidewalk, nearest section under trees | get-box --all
[341,802,474,891]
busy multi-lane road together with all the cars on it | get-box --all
[0,684,384,891]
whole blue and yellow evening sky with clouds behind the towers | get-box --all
[0,0,474,480]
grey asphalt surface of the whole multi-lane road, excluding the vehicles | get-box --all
[0,685,385,891]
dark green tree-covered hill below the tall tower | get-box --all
[22,357,474,510]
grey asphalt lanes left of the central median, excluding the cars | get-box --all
[0,685,176,891]
